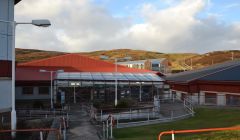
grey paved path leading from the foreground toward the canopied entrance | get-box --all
[67,105,99,140]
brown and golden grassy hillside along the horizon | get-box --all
[16,49,240,70]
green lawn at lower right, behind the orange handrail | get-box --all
[114,108,240,140]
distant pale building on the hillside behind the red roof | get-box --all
[118,58,170,73]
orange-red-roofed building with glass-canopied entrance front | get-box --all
[16,54,163,107]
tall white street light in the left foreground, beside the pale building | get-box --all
[0,19,51,137]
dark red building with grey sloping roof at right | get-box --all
[165,60,240,106]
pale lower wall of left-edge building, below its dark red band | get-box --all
[0,79,12,112]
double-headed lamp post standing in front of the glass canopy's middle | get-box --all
[100,55,132,106]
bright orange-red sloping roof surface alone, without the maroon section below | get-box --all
[18,54,152,73]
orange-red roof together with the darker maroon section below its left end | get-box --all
[16,54,152,81]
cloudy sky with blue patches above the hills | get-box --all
[15,0,240,53]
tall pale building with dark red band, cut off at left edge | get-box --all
[0,0,20,128]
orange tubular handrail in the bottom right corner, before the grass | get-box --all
[158,127,240,140]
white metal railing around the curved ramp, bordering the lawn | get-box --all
[90,99,194,128]
